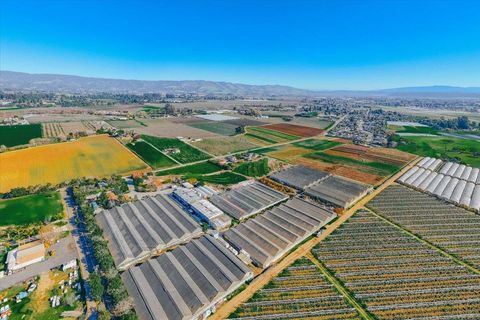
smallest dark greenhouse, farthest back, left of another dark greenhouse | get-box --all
[270,166,329,190]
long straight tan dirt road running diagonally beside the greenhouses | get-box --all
[211,154,419,319]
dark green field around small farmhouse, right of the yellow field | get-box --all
[142,135,210,163]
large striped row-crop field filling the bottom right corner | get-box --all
[312,210,480,319]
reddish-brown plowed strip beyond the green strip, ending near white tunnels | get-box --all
[330,144,415,166]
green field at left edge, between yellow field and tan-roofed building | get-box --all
[0,192,63,226]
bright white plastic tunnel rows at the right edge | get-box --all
[397,157,480,211]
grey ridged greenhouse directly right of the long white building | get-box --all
[210,182,288,220]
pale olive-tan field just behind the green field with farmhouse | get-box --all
[193,135,259,156]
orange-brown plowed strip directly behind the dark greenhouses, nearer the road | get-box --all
[294,157,385,185]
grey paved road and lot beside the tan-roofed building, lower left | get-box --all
[0,236,78,291]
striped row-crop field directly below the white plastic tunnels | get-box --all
[367,185,480,270]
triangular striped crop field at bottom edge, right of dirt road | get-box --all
[229,258,361,320]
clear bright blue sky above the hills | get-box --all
[0,0,480,89]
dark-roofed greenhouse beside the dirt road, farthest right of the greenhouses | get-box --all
[305,175,371,208]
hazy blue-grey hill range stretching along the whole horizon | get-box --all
[0,71,480,98]
